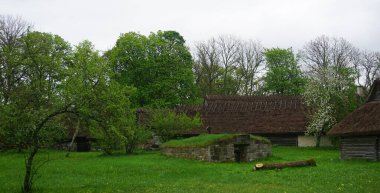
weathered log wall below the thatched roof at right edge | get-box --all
[340,136,379,161]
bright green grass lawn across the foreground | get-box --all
[0,147,380,193]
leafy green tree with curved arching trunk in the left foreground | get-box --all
[0,32,135,192]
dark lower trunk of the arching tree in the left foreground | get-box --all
[22,146,38,193]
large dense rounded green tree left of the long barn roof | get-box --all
[107,31,195,107]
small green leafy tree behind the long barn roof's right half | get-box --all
[264,48,305,95]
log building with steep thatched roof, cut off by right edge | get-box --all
[328,79,380,161]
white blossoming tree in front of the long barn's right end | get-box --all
[303,68,356,147]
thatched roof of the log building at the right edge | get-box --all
[328,79,380,136]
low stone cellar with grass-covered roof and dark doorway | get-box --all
[161,134,272,162]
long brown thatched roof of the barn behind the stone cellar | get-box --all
[186,96,307,134]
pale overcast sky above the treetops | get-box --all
[0,0,380,51]
